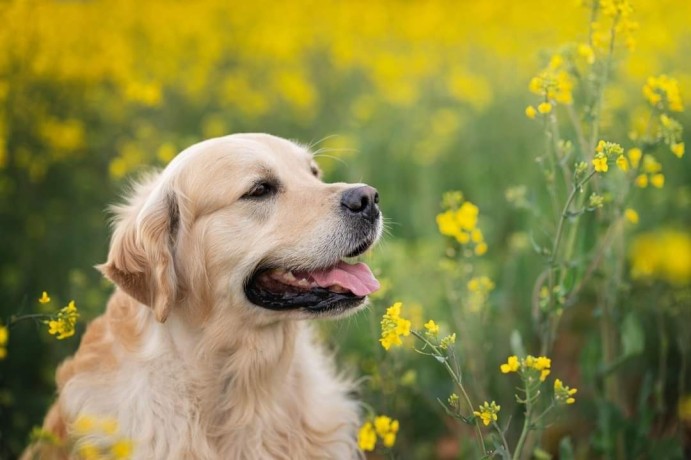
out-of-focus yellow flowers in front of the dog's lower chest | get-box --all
[71,415,134,460]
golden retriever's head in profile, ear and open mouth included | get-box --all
[99,134,382,321]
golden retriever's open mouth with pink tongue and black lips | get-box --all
[245,261,379,312]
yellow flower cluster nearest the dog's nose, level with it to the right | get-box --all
[437,192,487,255]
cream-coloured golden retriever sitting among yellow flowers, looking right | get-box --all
[24,134,382,460]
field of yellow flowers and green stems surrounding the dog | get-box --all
[0,0,691,460]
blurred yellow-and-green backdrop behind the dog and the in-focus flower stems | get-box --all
[0,0,691,458]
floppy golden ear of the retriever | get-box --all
[96,187,180,322]
